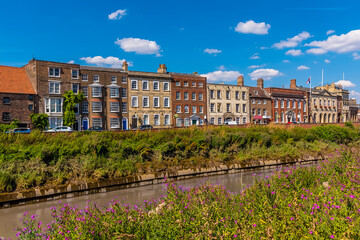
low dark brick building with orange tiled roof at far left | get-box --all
[0,66,36,127]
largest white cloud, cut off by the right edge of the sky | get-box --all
[305,30,360,54]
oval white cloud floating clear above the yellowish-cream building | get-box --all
[115,38,160,56]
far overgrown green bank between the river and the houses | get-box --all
[0,125,360,193]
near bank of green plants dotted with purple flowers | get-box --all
[17,147,360,239]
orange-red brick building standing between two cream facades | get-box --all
[170,73,207,127]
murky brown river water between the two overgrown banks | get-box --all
[0,164,310,239]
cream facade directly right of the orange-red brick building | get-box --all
[207,83,250,125]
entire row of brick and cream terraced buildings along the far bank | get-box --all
[0,59,358,130]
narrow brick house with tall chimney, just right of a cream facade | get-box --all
[249,78,273,124]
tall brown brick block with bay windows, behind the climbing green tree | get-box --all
[25,59,127,130]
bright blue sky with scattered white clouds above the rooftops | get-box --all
[0,0,360,100]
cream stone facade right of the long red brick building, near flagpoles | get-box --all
[310,90,339,123]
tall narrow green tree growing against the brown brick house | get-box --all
[63,90,84,127]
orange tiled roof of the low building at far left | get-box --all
[0,66,35,94]
